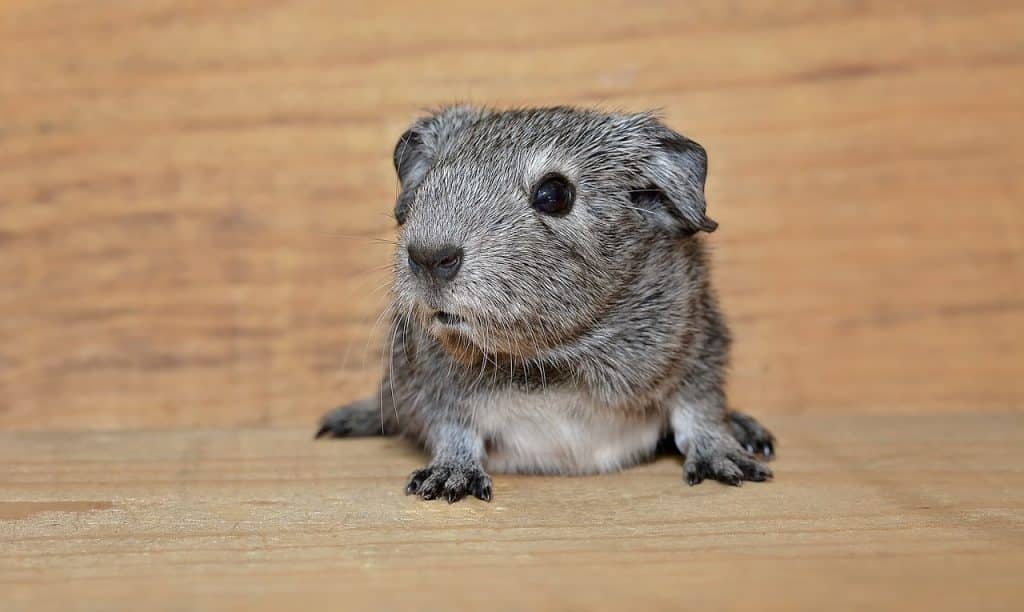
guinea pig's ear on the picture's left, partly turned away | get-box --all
[393,105,484,225]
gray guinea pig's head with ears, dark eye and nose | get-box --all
[393,106,717,358]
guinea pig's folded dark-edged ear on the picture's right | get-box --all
[630,127,718,236]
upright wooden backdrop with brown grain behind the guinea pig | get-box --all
[0,0,1024,429]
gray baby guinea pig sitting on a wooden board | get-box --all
[317,105,774,501]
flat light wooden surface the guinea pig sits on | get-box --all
[0,413,1024,612]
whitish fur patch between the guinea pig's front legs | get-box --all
[473,392,664,474]
